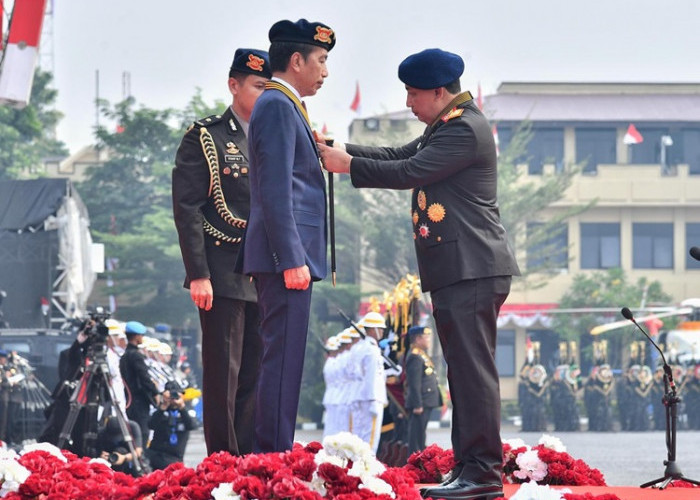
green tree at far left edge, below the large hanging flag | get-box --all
[0,69,68,180]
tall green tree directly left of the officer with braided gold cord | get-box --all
[78,98,195,325]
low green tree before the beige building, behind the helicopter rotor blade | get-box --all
[553,268,672,366]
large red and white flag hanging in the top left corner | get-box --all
[0,0,46,108]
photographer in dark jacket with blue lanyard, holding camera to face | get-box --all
[146,380,196,469]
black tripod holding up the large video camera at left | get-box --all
[58,344,143,476]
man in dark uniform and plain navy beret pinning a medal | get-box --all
[319,49,519,499]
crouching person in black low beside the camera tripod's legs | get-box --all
[97,417,149,477]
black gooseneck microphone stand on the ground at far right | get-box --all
[621,307,700,490]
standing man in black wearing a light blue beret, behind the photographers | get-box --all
[119,321,160,441]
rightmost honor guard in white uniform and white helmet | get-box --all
[352,312,387,454]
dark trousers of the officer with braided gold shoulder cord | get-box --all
[199,297,262,455]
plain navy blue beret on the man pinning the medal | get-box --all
[399,49,464,89]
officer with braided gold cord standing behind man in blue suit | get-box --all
[172,49,272,455]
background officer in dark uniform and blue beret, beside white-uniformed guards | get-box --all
[405,326,442,455]
